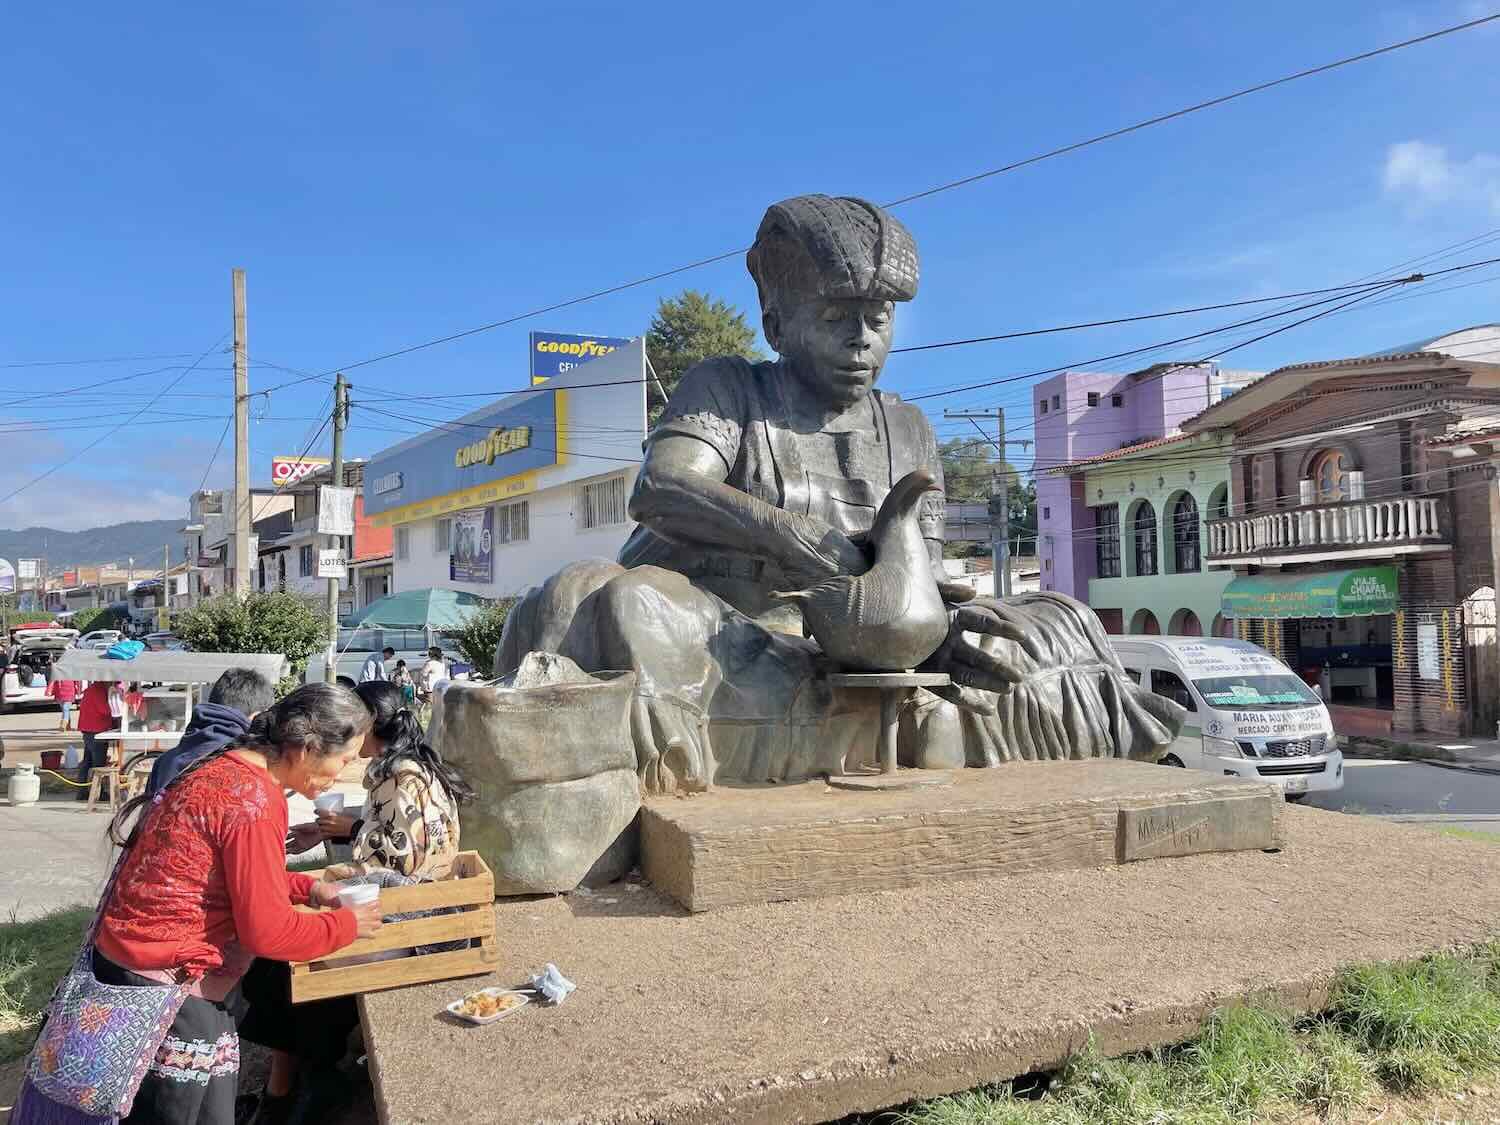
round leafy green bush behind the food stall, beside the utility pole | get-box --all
[177,591,329,696]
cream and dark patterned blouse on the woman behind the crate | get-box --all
[324,759,459,879]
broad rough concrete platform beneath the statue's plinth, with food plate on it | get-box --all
[360,810,1500,1125]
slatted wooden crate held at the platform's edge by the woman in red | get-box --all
[291,852,500,1004]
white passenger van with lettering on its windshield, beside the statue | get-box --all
[1110,636,1344,801]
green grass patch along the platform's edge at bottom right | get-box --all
[894,942,1500,1125]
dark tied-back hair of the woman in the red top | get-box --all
[110,684,371,848]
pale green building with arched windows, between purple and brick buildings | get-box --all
[1043,434,1235,636]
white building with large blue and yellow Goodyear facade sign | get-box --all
[365,339,647,597]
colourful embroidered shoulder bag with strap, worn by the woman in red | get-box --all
[11,855,192,1125]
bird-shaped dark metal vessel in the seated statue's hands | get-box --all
[771,470,948,672]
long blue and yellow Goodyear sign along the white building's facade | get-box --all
[365,390,567,527]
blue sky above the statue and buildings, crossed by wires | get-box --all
[0,0,1500,528]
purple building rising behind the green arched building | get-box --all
[1032,363,1263,602]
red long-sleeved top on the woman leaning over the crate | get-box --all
[98,753,356,977]
